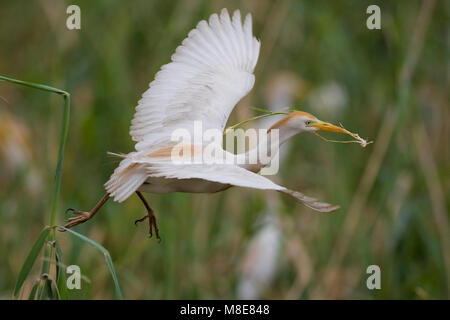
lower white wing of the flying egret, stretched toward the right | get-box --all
[147,163,340,212]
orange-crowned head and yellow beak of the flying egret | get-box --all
[271,111,346,133]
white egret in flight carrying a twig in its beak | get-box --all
[65,9,364,239]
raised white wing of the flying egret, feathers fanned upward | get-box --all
[130,9,260,151]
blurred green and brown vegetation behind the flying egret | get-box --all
[0,0,450,299]
